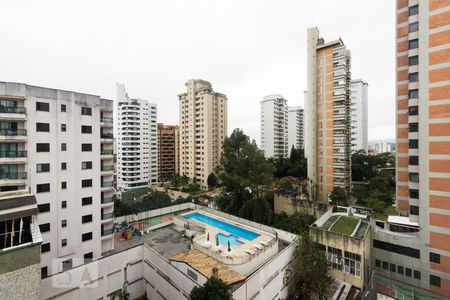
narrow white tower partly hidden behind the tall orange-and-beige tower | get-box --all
[350,79,369,153]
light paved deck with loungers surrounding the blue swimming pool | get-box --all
[181,211,277,265]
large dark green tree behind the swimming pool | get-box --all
[216,129,274,215]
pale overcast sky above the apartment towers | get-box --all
[0,0,395,142]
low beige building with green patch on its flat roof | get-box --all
[310,206,371,290]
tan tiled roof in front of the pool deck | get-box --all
[171,249,246,284]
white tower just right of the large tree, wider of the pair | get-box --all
[260,94,290,158]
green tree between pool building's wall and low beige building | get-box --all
[288,232,331,299]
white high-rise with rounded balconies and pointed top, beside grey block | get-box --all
[116,84,158,191]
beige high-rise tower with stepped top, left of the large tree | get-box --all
[178,79,228,189]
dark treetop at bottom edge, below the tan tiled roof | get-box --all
[189,276,233,300]
